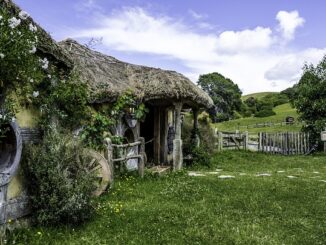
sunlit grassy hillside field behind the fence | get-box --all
[214,103,302,134]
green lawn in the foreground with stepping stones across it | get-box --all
[8,151,326,245]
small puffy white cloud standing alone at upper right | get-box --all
[276,11,305,41]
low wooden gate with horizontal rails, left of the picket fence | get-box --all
[217,132,248,151]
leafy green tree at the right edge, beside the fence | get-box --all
[293,55,326,144]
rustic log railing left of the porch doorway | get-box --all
[105,137,146,177]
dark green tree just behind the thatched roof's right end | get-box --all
[198,72,242,122]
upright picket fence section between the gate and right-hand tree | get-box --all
[258,132,311,155]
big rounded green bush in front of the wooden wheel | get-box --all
[23,132,95,225]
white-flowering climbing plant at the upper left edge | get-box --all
[0,6,48,138]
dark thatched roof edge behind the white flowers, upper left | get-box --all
[0,0,72,68]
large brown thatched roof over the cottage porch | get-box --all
[59,39,213,108]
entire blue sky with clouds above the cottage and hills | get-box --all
[15,0,326,94]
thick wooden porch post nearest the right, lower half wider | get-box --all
[173,102,183,170]
